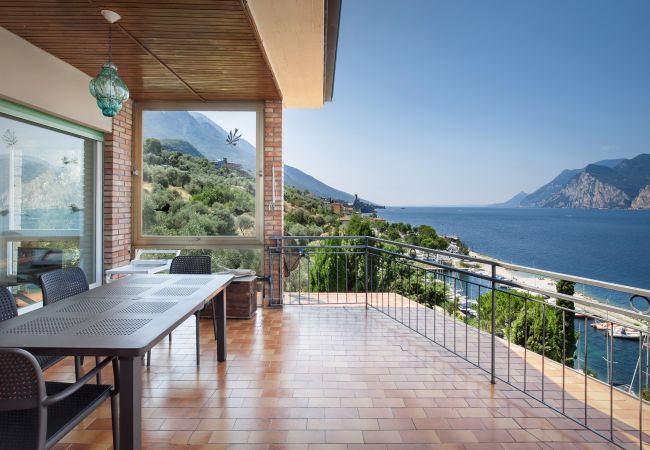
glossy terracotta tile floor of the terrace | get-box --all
[48,299,638,450]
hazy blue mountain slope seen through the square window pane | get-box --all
[143,111,255,171]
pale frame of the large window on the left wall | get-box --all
[0,99,104,298]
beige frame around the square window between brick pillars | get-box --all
[132,100,264,249]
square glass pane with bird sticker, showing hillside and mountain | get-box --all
[142,111,257,237]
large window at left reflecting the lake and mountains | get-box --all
[0,105,101,307]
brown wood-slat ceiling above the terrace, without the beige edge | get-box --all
[0,0,281,100]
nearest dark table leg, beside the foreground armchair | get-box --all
[119,357,142,450]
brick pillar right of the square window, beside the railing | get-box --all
[264,100,284,300]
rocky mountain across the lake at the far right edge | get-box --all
[521,154,650,209]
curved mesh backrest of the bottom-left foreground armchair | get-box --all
[0,348,47,449]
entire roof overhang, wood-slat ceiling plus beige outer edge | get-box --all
[0,0,340,111]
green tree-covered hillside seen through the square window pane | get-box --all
[142,138,255,236]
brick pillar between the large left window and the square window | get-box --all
[104,100,133,278]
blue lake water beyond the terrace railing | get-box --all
[378,207,650,385]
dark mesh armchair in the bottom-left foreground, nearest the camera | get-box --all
[0,348,119,450]
